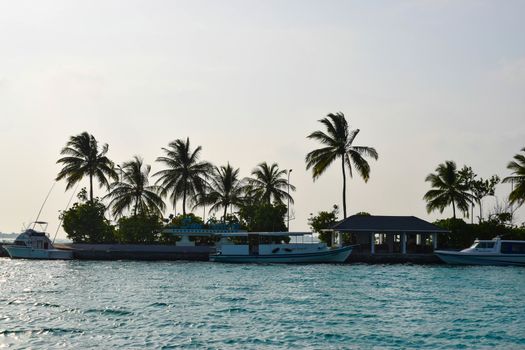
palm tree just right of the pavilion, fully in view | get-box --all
[423,161,473,219]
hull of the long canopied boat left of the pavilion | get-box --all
[210,246,353,264]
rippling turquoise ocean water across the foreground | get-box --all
[0,258,525,349]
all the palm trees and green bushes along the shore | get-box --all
[57,129,525,247]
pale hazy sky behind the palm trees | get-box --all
[0,0,525,238]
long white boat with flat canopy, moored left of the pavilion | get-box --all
[210,232,352,264]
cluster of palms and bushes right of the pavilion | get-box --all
[423,147,525,248]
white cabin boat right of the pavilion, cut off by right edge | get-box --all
[434,237,525,266]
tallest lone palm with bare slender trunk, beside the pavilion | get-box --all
[305,113,378,218]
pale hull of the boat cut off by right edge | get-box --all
[434,250,525,266]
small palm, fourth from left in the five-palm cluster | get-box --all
[199,163,244,222]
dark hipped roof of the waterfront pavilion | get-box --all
[332,215,449,233]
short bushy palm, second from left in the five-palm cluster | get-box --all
[104,156,166,216]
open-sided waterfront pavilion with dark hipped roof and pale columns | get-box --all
[331,215,450,255]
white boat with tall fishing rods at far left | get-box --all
[4,221,73,260]
